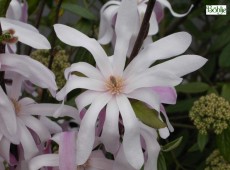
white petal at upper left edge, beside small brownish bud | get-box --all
[0,18,51,49]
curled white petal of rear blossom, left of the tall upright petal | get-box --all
[98,1,120,44]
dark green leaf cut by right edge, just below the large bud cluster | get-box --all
[216,128,230,161]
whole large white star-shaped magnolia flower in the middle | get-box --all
[54,0,207,169]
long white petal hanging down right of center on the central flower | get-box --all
[116,94,144,169]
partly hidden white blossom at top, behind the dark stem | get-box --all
[98,0,193,45]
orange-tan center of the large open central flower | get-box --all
[106,76,124,94]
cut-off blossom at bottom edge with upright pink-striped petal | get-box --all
[28,131,113,170]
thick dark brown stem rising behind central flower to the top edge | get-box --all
[129,0,156,61]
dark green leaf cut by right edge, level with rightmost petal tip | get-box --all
[219,43,230,68]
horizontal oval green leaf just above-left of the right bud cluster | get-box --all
[176,82,209,93]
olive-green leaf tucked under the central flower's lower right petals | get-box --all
[132,102,166,129]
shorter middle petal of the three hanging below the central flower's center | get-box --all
[101,98,120,153]
